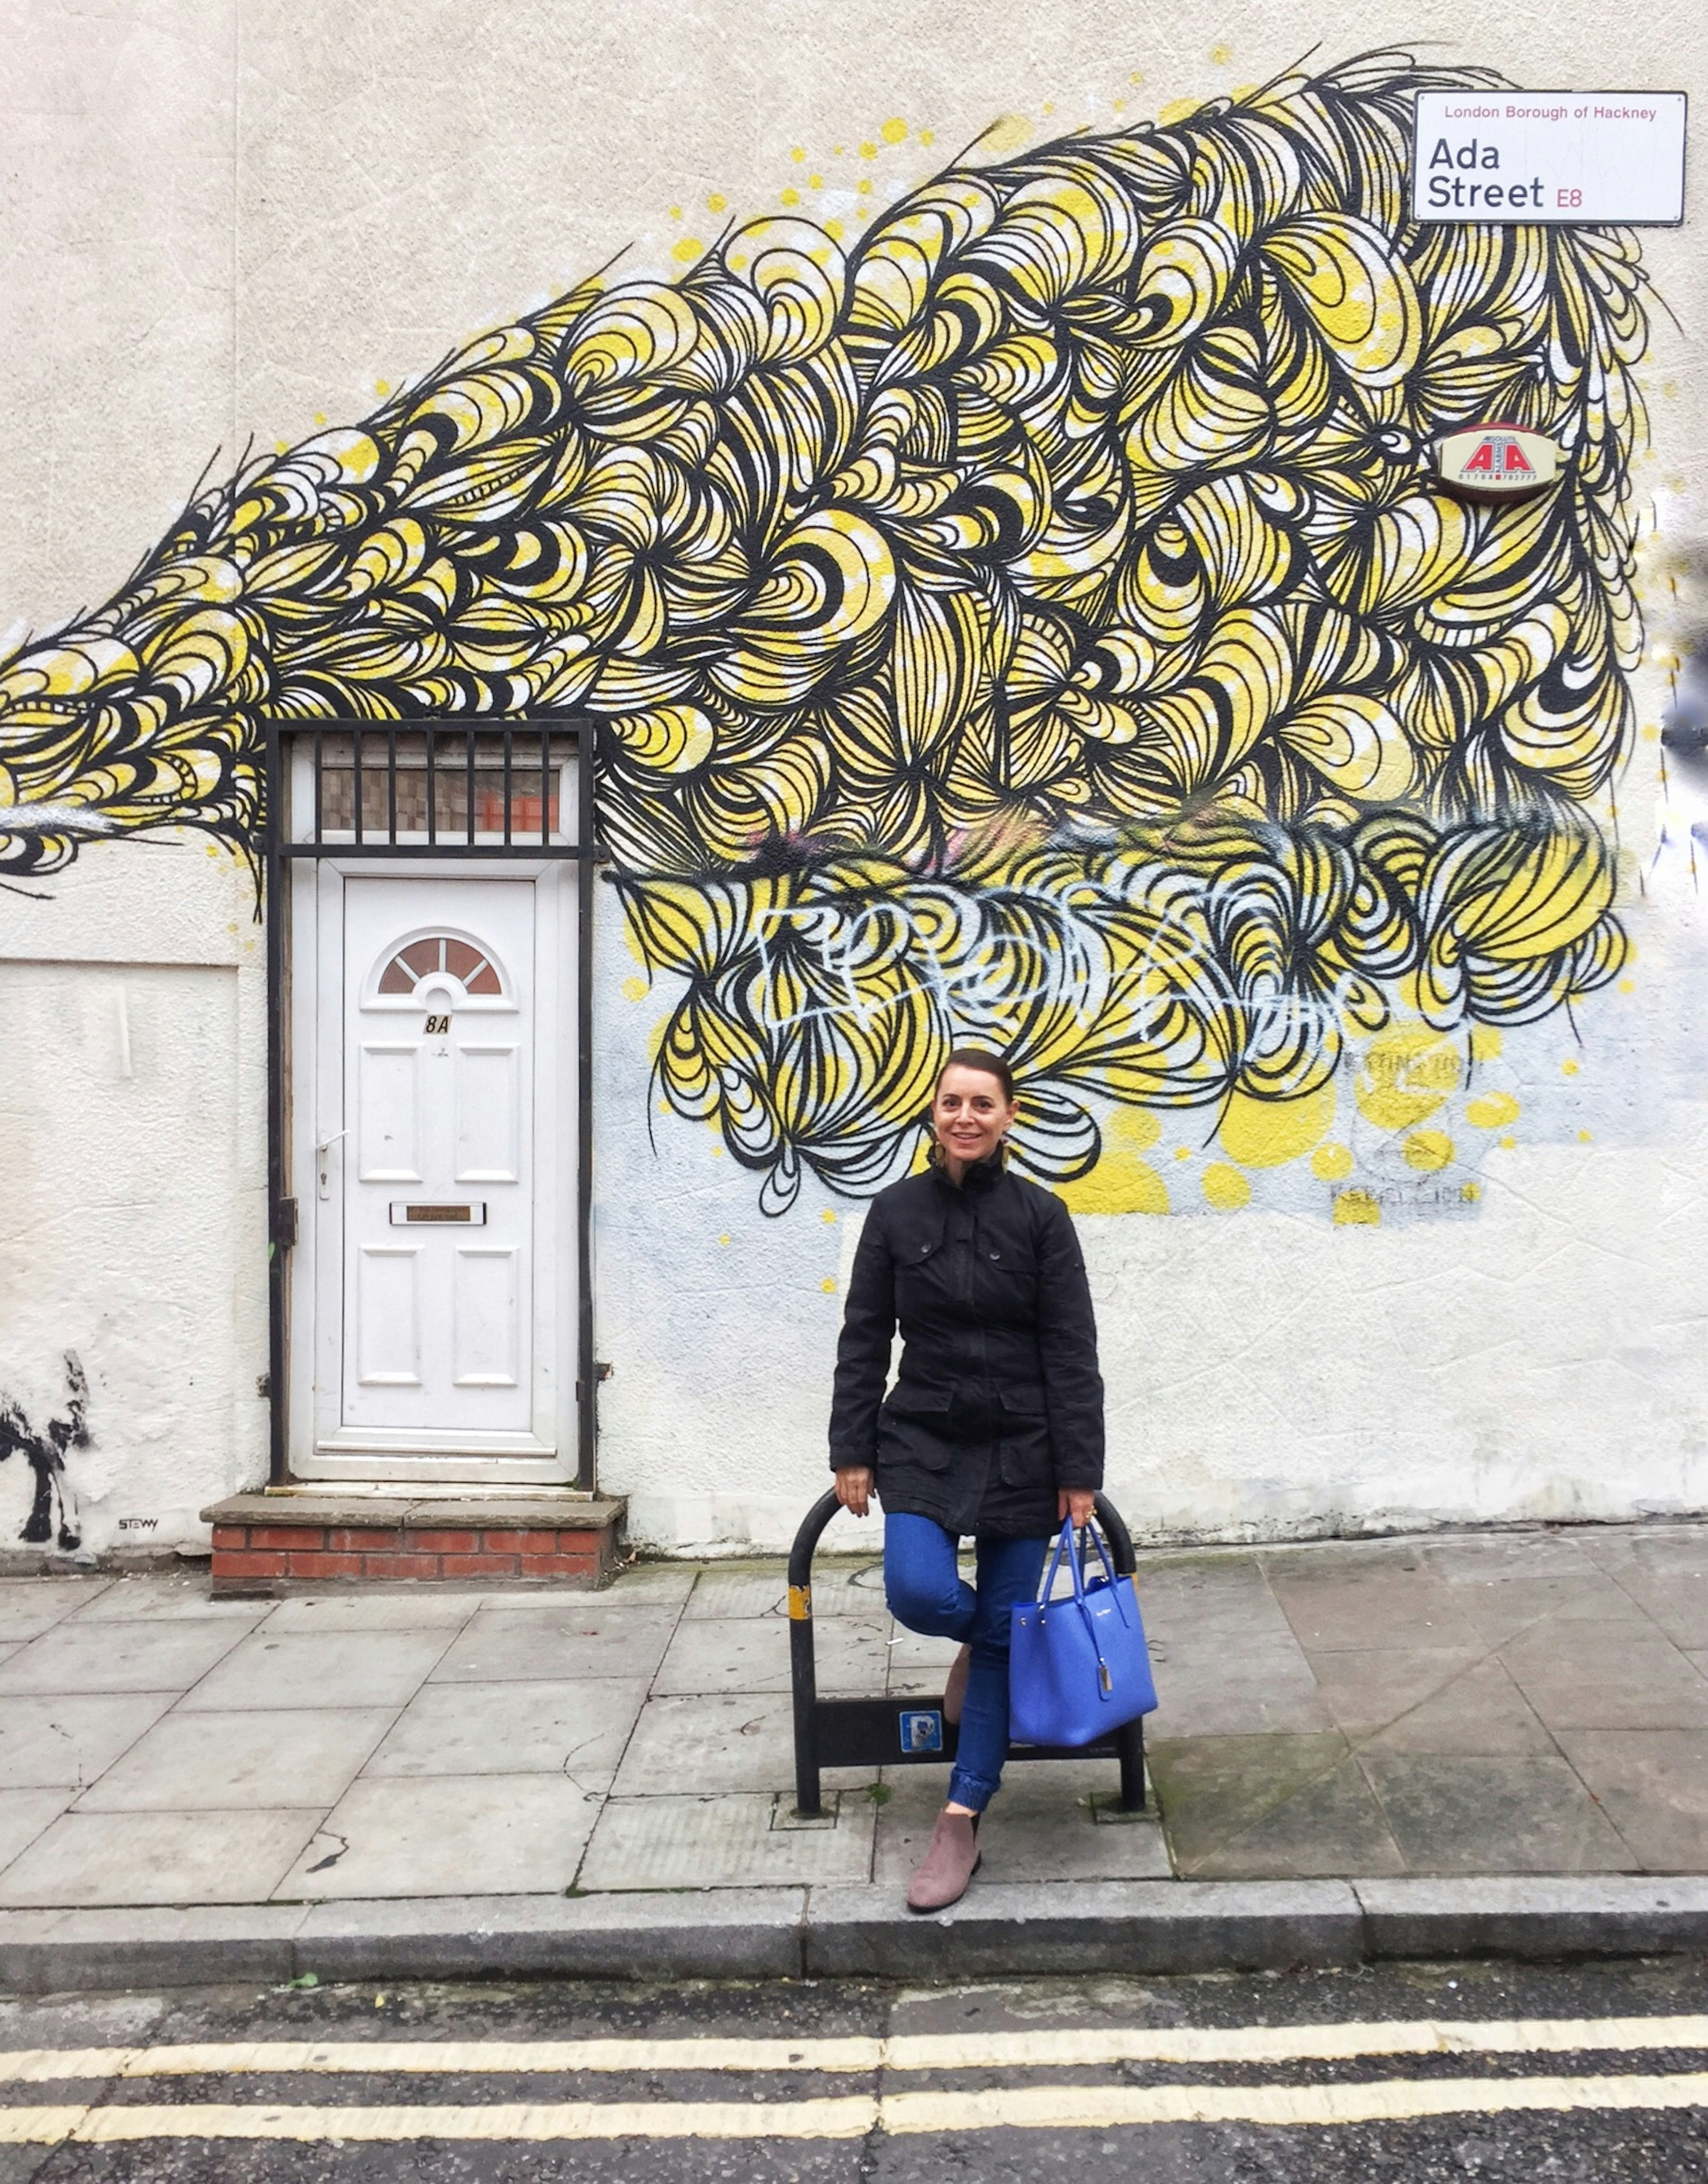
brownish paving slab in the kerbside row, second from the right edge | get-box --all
[1361,1752,1636,1874]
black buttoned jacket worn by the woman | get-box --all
[830,1160,1103,1538]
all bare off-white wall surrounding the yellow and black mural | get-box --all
[0,0,1708,1550]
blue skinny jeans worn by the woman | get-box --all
[885,1514,1051,1813]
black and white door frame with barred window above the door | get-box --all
[262,719,598,1496]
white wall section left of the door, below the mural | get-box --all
[0,843,266,1553]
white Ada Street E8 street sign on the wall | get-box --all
[1411,89,1686,227]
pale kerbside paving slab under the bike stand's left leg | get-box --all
[576,1791,876,1889]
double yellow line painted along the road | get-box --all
[0,2016,1708,2145]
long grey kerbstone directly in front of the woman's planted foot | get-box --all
[806,1876,1363,1981]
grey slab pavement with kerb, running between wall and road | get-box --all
[0,1524,1708,1987]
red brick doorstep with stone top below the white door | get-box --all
[201,1492,627,1596]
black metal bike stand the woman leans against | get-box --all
[789,1492,1144,1819]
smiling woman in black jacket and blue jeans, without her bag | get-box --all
[830,1048,1103,1911]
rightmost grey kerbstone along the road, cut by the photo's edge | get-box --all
[1352,1874,1708,1959]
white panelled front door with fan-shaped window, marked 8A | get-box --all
[293,865,574,1481]
